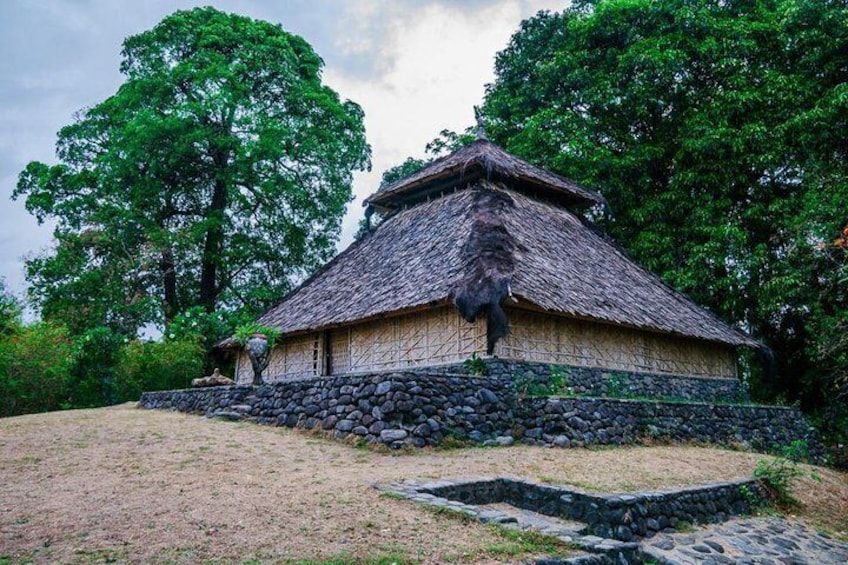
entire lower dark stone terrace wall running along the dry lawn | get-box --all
[139,371,823,456]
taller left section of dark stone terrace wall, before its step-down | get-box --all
[140,372,514,447]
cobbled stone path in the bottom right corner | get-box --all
[640,518,848,565]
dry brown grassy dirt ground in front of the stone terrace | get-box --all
[0,405,848,565]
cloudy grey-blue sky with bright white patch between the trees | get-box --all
[0,0,566,304]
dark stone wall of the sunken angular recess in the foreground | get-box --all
[416,479,765,541]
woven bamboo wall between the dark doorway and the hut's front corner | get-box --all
[329,306,486,375]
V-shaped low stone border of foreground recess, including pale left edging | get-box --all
[375,478,764,565]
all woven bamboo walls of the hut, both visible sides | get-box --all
[236,306,736,384]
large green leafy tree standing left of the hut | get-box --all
[15,8,370,332]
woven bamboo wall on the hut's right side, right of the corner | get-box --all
[495,309,736,377]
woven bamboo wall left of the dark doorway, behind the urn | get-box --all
[236,333,324,384]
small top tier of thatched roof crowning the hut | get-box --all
[365,138,604,210]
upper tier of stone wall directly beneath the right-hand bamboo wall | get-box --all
[402,358,750,403]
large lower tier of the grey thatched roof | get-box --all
[260,181,757,346]
